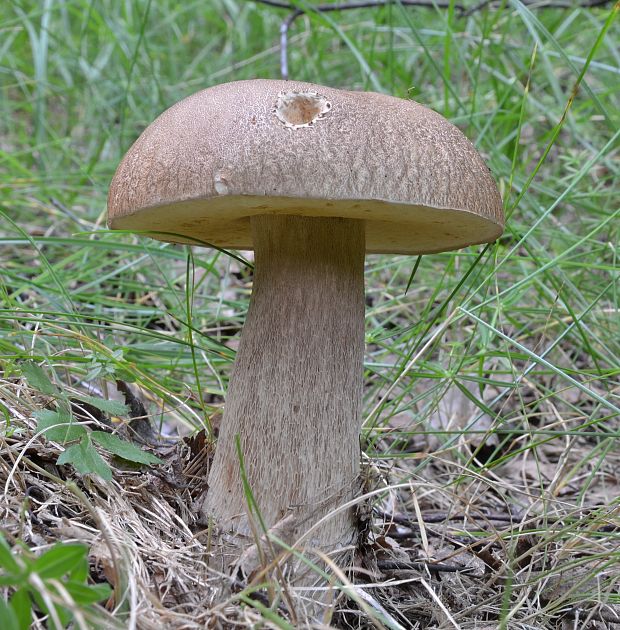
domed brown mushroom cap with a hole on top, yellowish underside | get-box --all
[108,79,504,254]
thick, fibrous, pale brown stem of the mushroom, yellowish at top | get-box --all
[204,215,365,557]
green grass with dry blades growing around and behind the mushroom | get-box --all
[0,0,620,628]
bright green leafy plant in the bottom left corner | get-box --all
[0,534,111,630]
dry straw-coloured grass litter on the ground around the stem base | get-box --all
[0,368,620,630]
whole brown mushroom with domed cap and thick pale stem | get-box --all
[108,80,504,572]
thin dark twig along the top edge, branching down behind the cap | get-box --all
[253,0,614,80]
